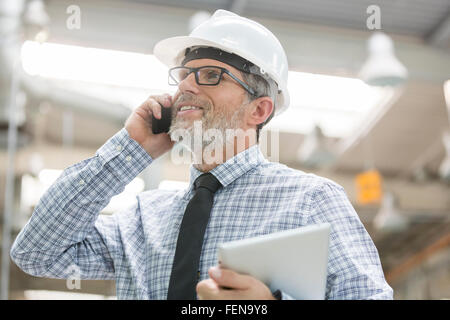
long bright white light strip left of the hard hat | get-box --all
[21,41,173,91]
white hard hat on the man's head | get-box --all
[153,9,289,115]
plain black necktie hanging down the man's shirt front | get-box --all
[167,172,222,300]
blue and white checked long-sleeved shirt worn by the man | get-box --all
[11,129,393,299]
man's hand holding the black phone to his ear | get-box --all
[125,94,175,159]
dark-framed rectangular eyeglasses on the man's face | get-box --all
[169,66,256,96]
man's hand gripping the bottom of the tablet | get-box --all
[197,267,275,300]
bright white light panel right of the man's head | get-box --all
[267,71,393,138]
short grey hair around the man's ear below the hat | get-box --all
[241,72,278,142]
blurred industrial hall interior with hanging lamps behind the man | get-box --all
[0,0,450,299]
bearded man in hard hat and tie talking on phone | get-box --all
[11,10,392,299]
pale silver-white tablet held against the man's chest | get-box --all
[218,223,330,300]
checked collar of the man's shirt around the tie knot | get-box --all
[189,144,268,189]
